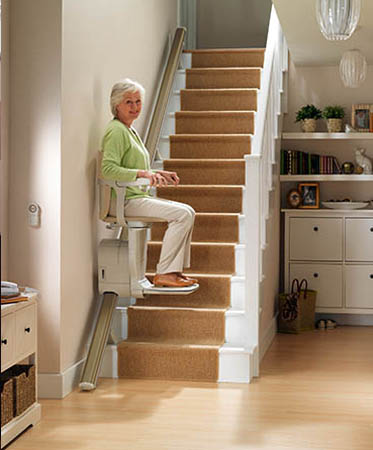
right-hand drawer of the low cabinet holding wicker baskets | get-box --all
[15,305,36,358]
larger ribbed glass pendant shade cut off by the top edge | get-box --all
[316,0,361,41]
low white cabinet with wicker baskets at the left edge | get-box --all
[1,294,41,448]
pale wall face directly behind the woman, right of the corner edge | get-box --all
[61,0,177,370]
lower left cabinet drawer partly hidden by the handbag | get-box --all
[288,264,343,308]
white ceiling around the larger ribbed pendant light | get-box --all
[273,0,373,66]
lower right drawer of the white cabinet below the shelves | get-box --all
[345,265,373,309]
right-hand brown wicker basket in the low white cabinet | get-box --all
[12,364,36,416]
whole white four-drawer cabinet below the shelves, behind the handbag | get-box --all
[283,209,373,314]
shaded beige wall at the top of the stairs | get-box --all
[197,0,272,48]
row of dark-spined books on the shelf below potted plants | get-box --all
[280,150,341,175]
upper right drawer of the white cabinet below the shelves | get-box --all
[346,219,373,261]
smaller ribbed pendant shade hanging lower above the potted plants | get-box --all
[339,50,367,88]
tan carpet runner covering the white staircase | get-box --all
[118,49,264,381]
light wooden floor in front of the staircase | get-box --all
[9,327,373,450]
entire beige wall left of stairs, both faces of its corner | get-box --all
[8,0,177,374]
